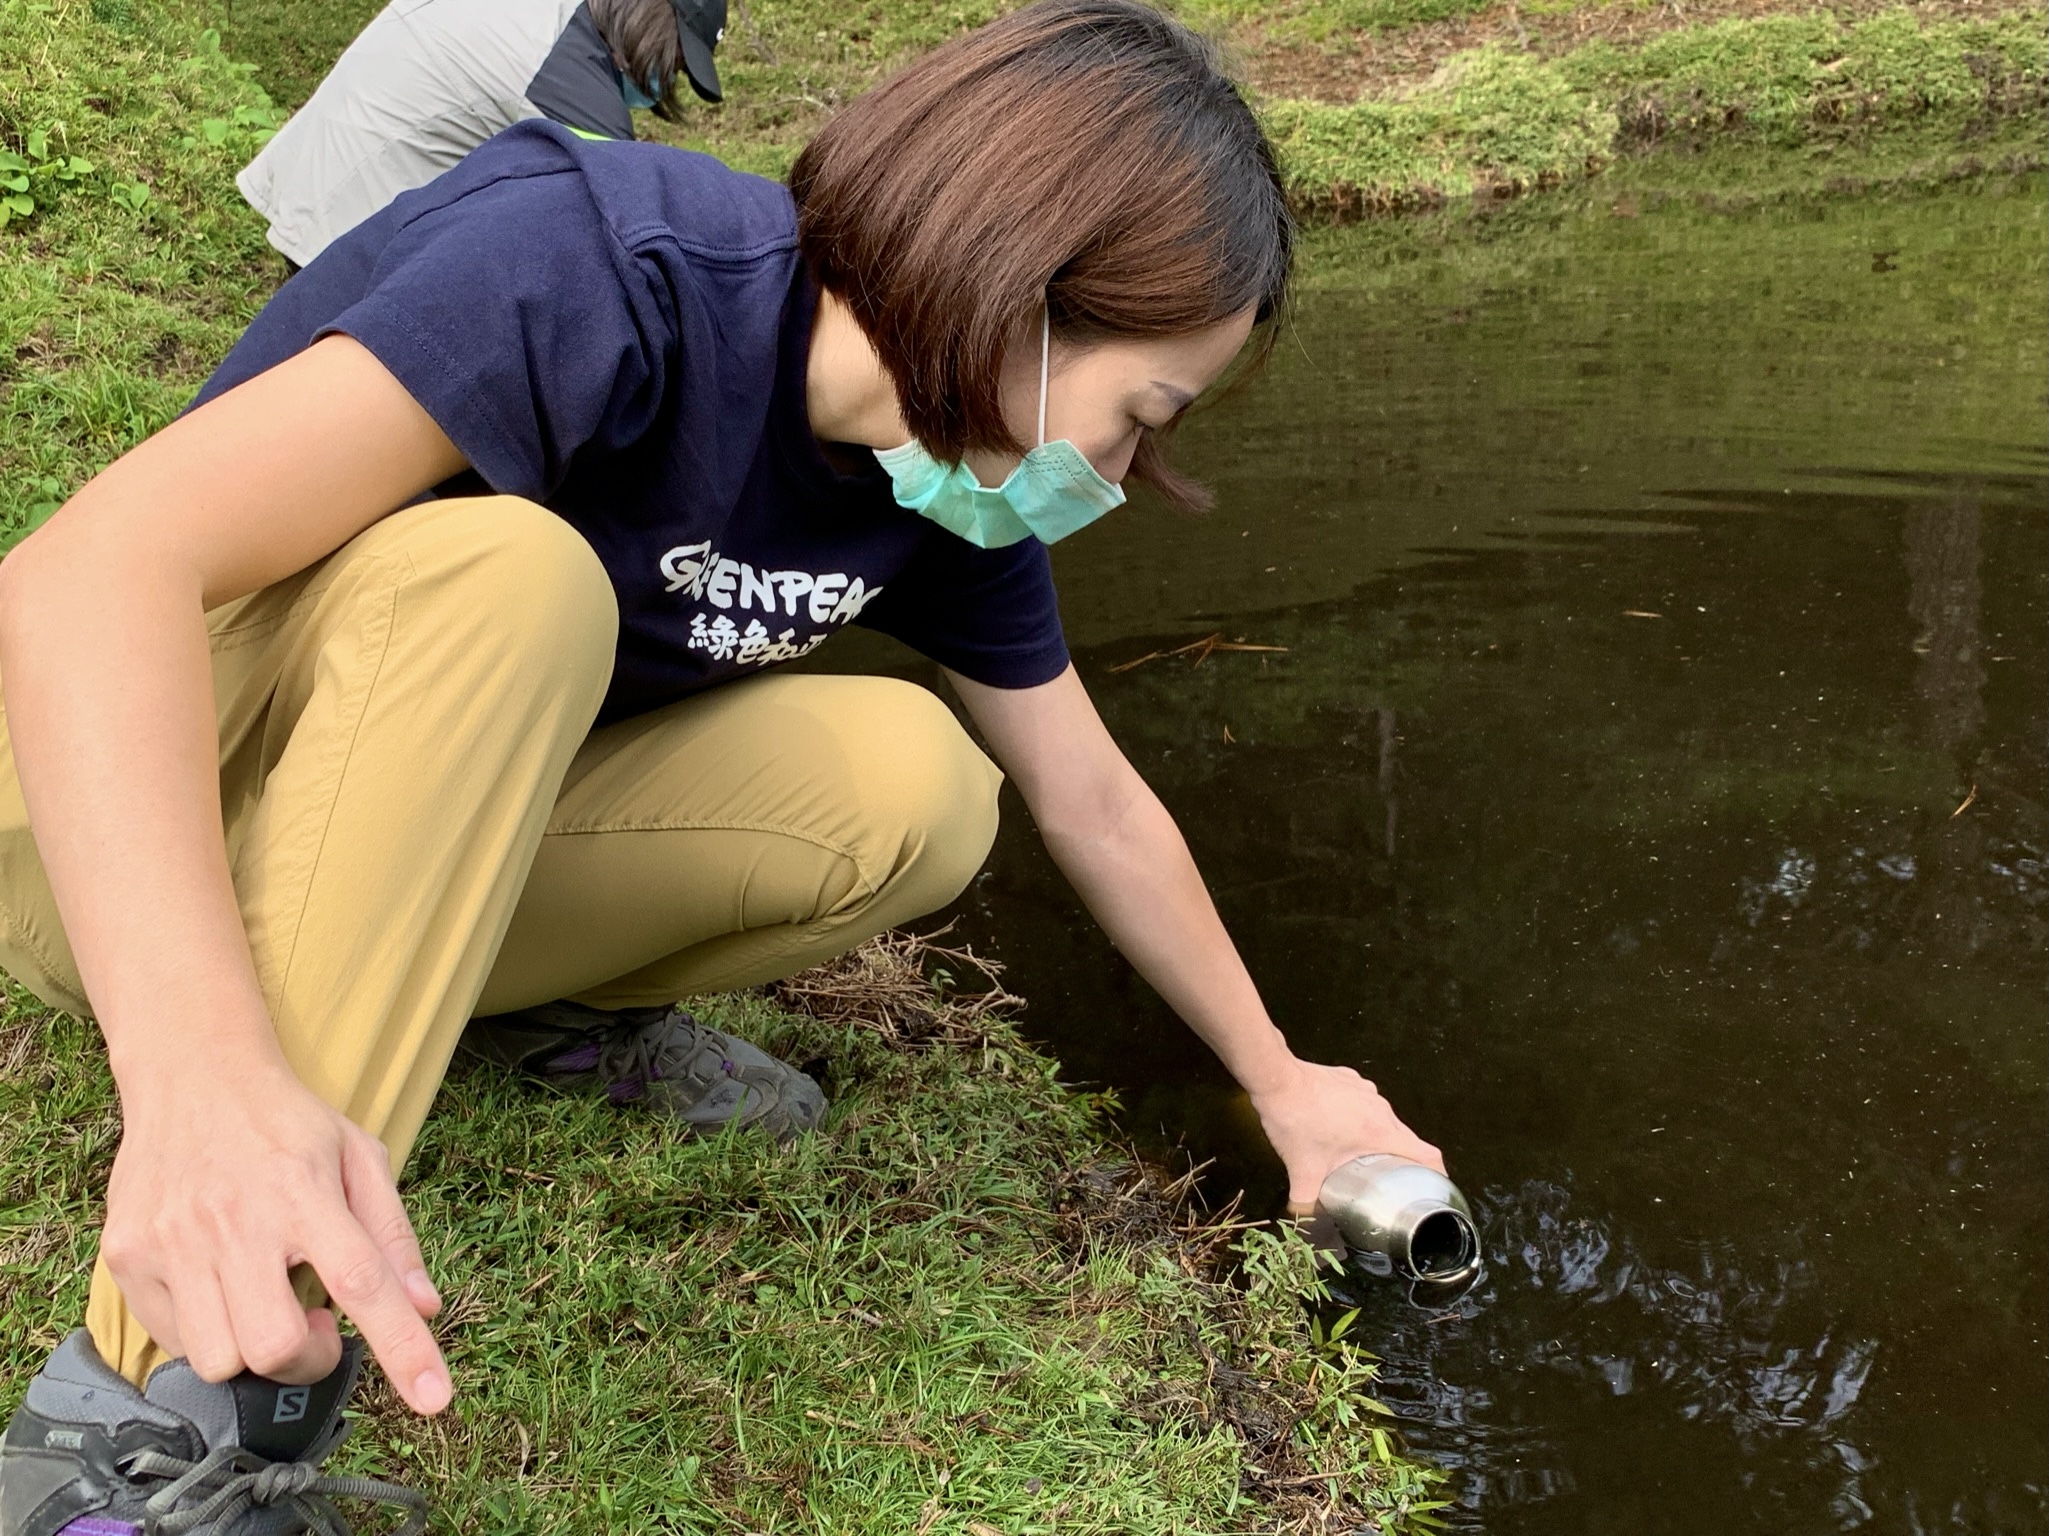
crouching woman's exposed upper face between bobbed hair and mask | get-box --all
[967,307,1254,485]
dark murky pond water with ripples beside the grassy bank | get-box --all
[823,162,2049,1536]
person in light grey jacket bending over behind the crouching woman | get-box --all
[236,0,725,266]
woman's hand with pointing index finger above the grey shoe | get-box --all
[100,1059,451,1413]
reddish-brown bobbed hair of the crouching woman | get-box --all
[789,0,1295,518]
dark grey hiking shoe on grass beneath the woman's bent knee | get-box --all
[463,1004,826,1143]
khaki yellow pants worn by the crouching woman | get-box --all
[0,498,1000,1384]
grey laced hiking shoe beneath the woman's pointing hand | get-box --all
[0,1329,426,1536]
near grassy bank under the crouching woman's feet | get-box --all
[0,946,1432,1536]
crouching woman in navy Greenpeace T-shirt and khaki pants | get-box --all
[0,0,1434,1536]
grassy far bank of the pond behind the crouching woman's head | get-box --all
[639,0,2049,198]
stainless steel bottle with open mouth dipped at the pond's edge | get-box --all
[1318,1153,1479,1290]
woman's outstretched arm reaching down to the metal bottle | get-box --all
[947,666,1445,1204]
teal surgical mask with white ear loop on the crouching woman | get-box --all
[875,309,1125,549]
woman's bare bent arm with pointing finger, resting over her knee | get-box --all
[0,336,463,1413]
